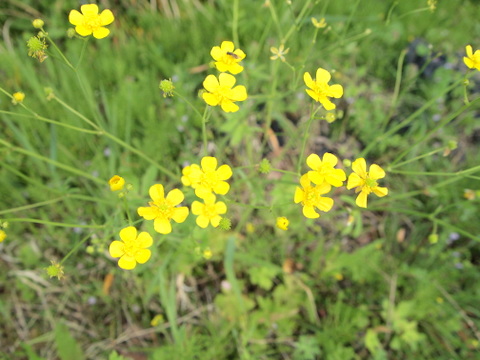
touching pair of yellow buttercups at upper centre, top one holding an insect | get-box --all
[202,41,247,112]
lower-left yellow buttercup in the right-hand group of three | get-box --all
[294,174,333,219]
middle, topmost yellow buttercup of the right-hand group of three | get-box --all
[307,153,347,187]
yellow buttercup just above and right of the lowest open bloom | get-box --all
[137,184,188,234]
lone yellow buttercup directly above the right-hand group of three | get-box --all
[303,68,343,110]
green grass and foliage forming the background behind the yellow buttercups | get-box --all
[0,0,480,360]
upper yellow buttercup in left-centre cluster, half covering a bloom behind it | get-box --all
[189,156,232,199]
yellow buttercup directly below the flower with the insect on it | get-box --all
[202,73,247,112]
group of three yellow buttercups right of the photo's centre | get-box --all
[294,153,388,219]
